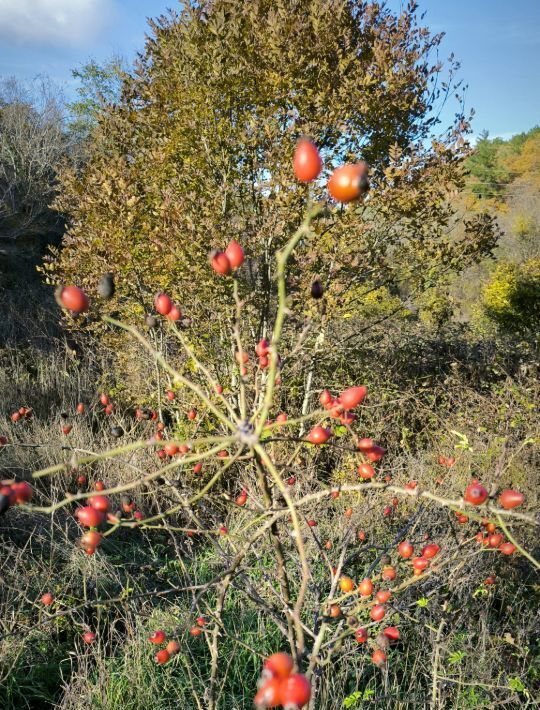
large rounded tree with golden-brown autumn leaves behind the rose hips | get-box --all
[46,0,495,378]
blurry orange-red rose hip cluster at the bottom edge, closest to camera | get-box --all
[253,652,311,710]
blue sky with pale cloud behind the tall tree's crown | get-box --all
[0,0,540,137]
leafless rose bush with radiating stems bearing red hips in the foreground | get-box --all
[0,138,539,710]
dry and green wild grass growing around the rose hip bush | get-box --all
[0,342,540,710]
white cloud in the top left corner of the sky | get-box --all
[0,0,114,47]
